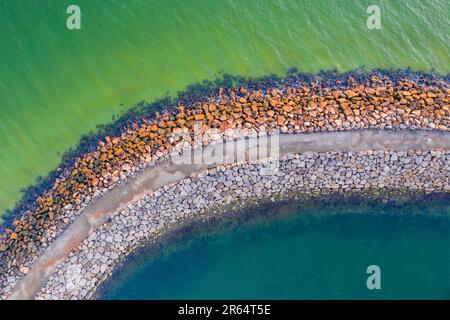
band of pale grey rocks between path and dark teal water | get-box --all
[31,150,450,299]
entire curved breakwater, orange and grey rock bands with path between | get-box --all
[0,73,450,298]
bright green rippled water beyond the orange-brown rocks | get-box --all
[0,0,450,216]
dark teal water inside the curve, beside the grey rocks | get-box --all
[100,199,450,299]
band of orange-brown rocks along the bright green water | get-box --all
[0,72,450,296]
